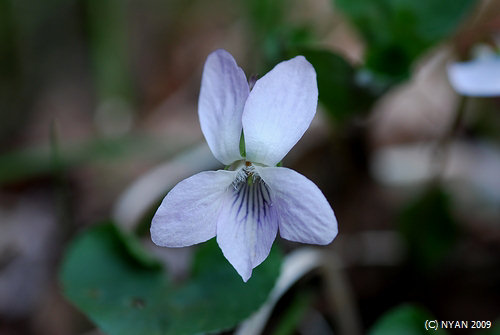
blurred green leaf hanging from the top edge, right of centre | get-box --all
[333,0,475,82]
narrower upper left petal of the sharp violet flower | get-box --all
[198,49,249,165]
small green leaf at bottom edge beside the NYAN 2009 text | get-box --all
[368,304,446,335]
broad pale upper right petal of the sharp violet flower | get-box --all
[243,56,318,166]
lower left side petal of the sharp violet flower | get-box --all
[151,170,236,247]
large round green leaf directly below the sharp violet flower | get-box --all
[60,224,281,335]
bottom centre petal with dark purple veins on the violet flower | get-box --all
[217,181,278,282]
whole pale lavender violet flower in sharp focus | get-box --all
[151,50,337,282]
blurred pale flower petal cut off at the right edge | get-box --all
[448,57,500,97]
